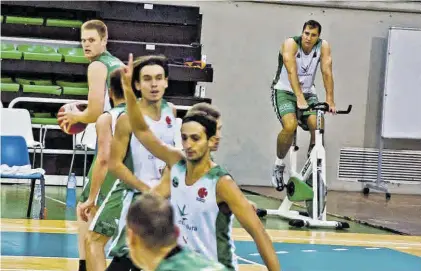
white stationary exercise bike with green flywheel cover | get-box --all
[257,103,352,229]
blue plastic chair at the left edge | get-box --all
[0,136,45,219]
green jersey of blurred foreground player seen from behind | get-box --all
[155,249,228,271]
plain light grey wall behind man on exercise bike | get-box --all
[149,1,421,192]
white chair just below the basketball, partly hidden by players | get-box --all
[69,123,96,186]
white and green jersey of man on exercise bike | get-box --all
[272,36,322,94]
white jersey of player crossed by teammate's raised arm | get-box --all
[124,100,176,190]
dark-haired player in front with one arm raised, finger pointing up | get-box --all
[122,54,280,271]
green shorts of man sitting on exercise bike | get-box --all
[271,89,319,131]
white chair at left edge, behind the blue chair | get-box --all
[0,108,44,168]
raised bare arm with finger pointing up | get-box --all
[121,54,183,167]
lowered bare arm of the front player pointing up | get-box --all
[216,175,281,271]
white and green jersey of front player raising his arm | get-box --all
[170,160,237,270]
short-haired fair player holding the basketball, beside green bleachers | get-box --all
[57,20,123,271]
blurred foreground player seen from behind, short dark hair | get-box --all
[127,194,228,271]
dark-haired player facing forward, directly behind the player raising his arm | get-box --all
[88,56,177,270]
